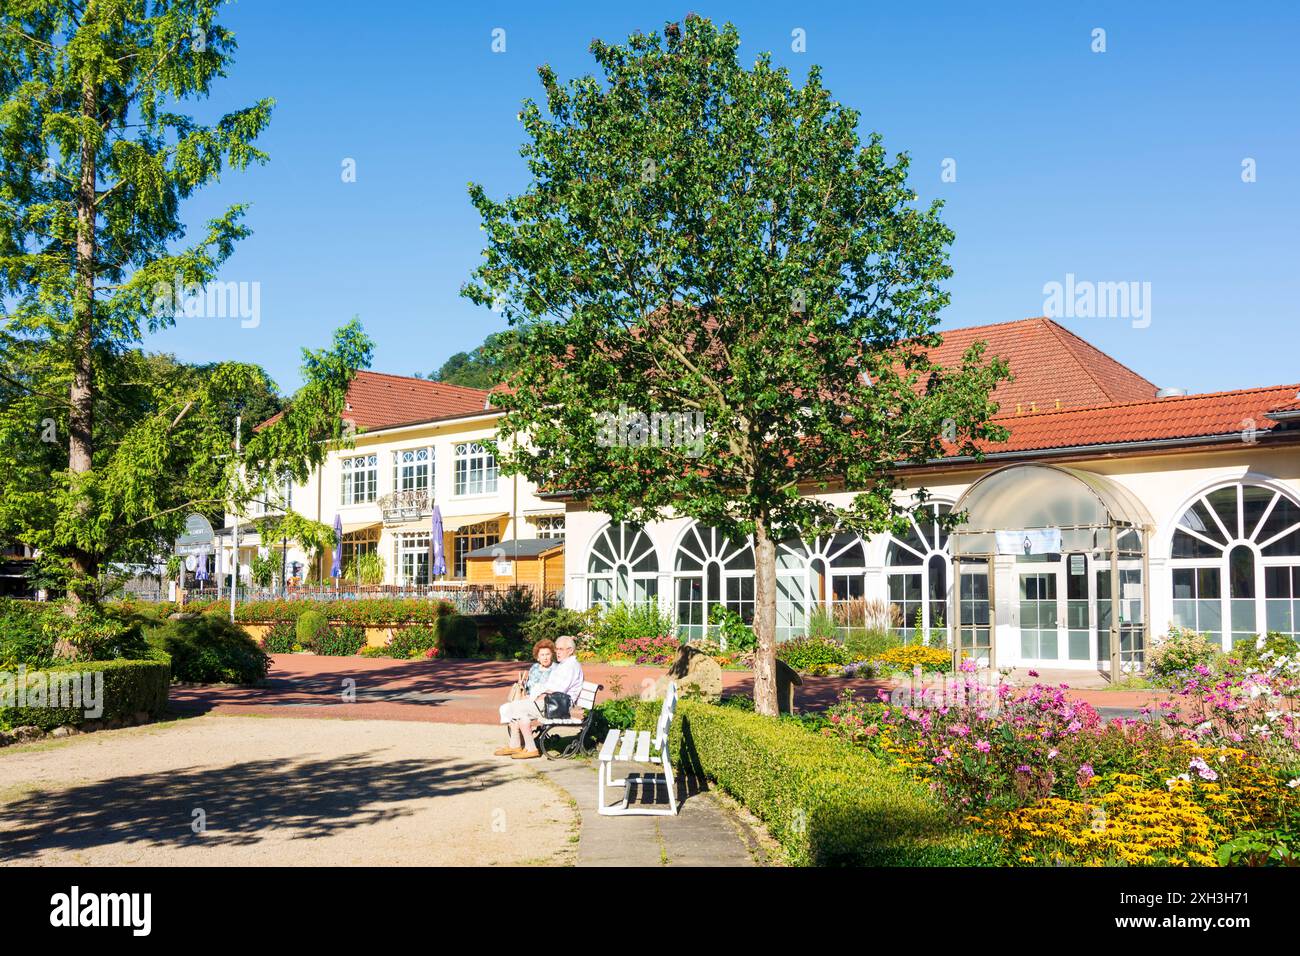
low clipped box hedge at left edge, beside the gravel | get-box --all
[0,661,172,731]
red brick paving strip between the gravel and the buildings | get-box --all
[162,654,1164,723]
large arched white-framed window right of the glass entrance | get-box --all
[1169,483,1300,649]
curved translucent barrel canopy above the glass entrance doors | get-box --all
[953,464,1152,555]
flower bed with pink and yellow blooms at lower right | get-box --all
[824,658,1300,865]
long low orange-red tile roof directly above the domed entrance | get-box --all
[967,385,1300,454]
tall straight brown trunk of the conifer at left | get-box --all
[68,77,98,605]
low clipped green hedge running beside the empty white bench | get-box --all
[636,700,995,866]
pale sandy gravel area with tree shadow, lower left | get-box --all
[0,714,577,866]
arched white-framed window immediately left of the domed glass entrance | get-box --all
[885,502,953,643]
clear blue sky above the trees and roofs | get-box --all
[148,0,1300,392]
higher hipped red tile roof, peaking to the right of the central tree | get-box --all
[931,319,1157,412]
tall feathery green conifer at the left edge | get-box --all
[0,0,371,601]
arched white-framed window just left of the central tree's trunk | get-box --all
[673,524,754,639]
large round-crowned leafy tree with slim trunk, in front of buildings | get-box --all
[463,17,1006,714]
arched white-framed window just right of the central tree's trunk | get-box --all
[776,532,867,640]
